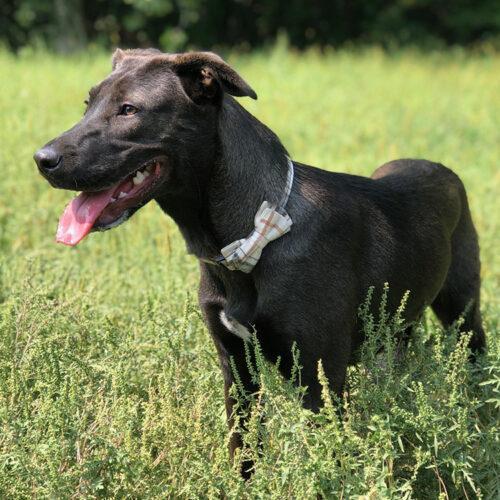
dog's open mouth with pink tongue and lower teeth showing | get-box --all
[56,160,163,246]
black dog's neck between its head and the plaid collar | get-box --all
[158,96,288,259]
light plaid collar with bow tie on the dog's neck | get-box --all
[201,157,294,273]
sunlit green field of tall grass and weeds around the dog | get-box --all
[0,49,500,499]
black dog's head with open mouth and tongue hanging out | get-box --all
[34,49,257,245]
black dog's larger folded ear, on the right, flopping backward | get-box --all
[171,52,257,103]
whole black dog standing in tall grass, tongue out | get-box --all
[35,50,485,466]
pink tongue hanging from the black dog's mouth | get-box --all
[56,186,116,246]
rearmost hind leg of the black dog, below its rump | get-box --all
[432,185,486,355]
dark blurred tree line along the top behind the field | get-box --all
[0,0,500,52]
